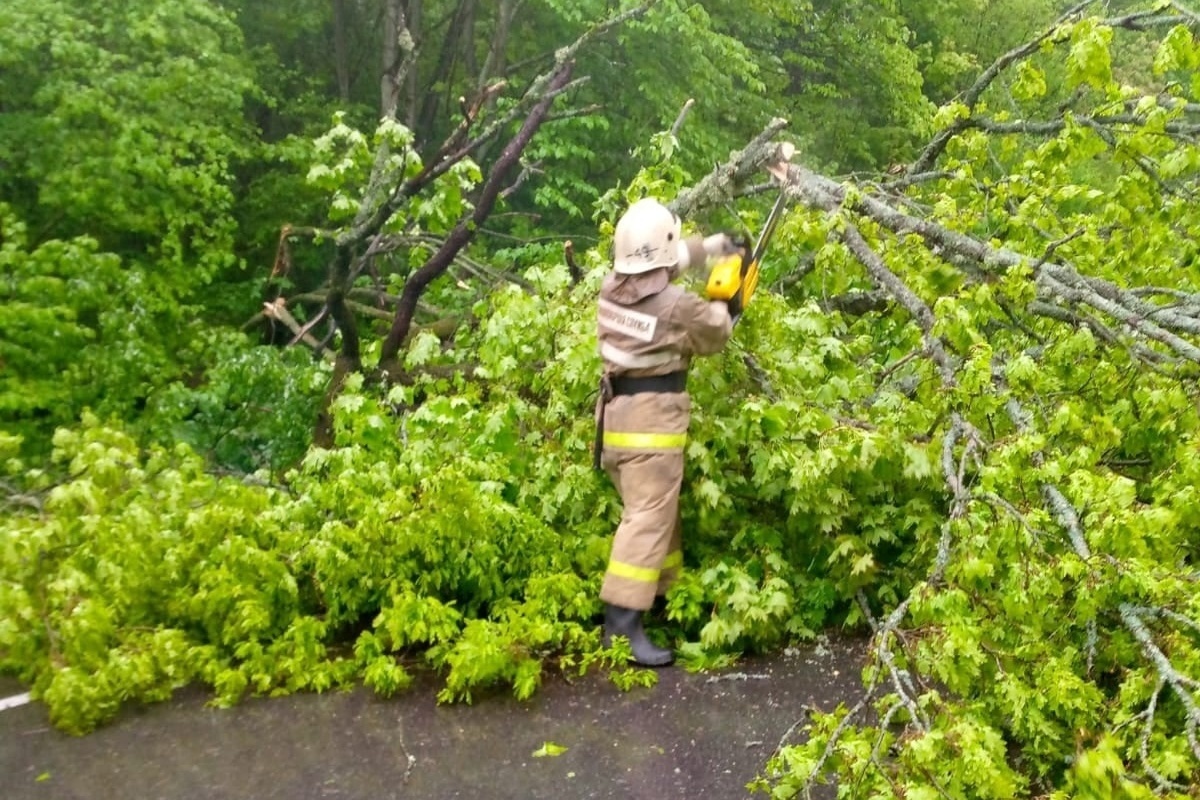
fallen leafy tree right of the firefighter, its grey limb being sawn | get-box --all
[679,2,1200,798]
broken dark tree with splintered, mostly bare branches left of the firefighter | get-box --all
[254,0,658,446]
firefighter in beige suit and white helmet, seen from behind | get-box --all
[596,199,740,667]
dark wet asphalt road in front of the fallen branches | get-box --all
[0,639,863,800]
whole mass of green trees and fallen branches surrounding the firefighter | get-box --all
[0,0,1200,799]
